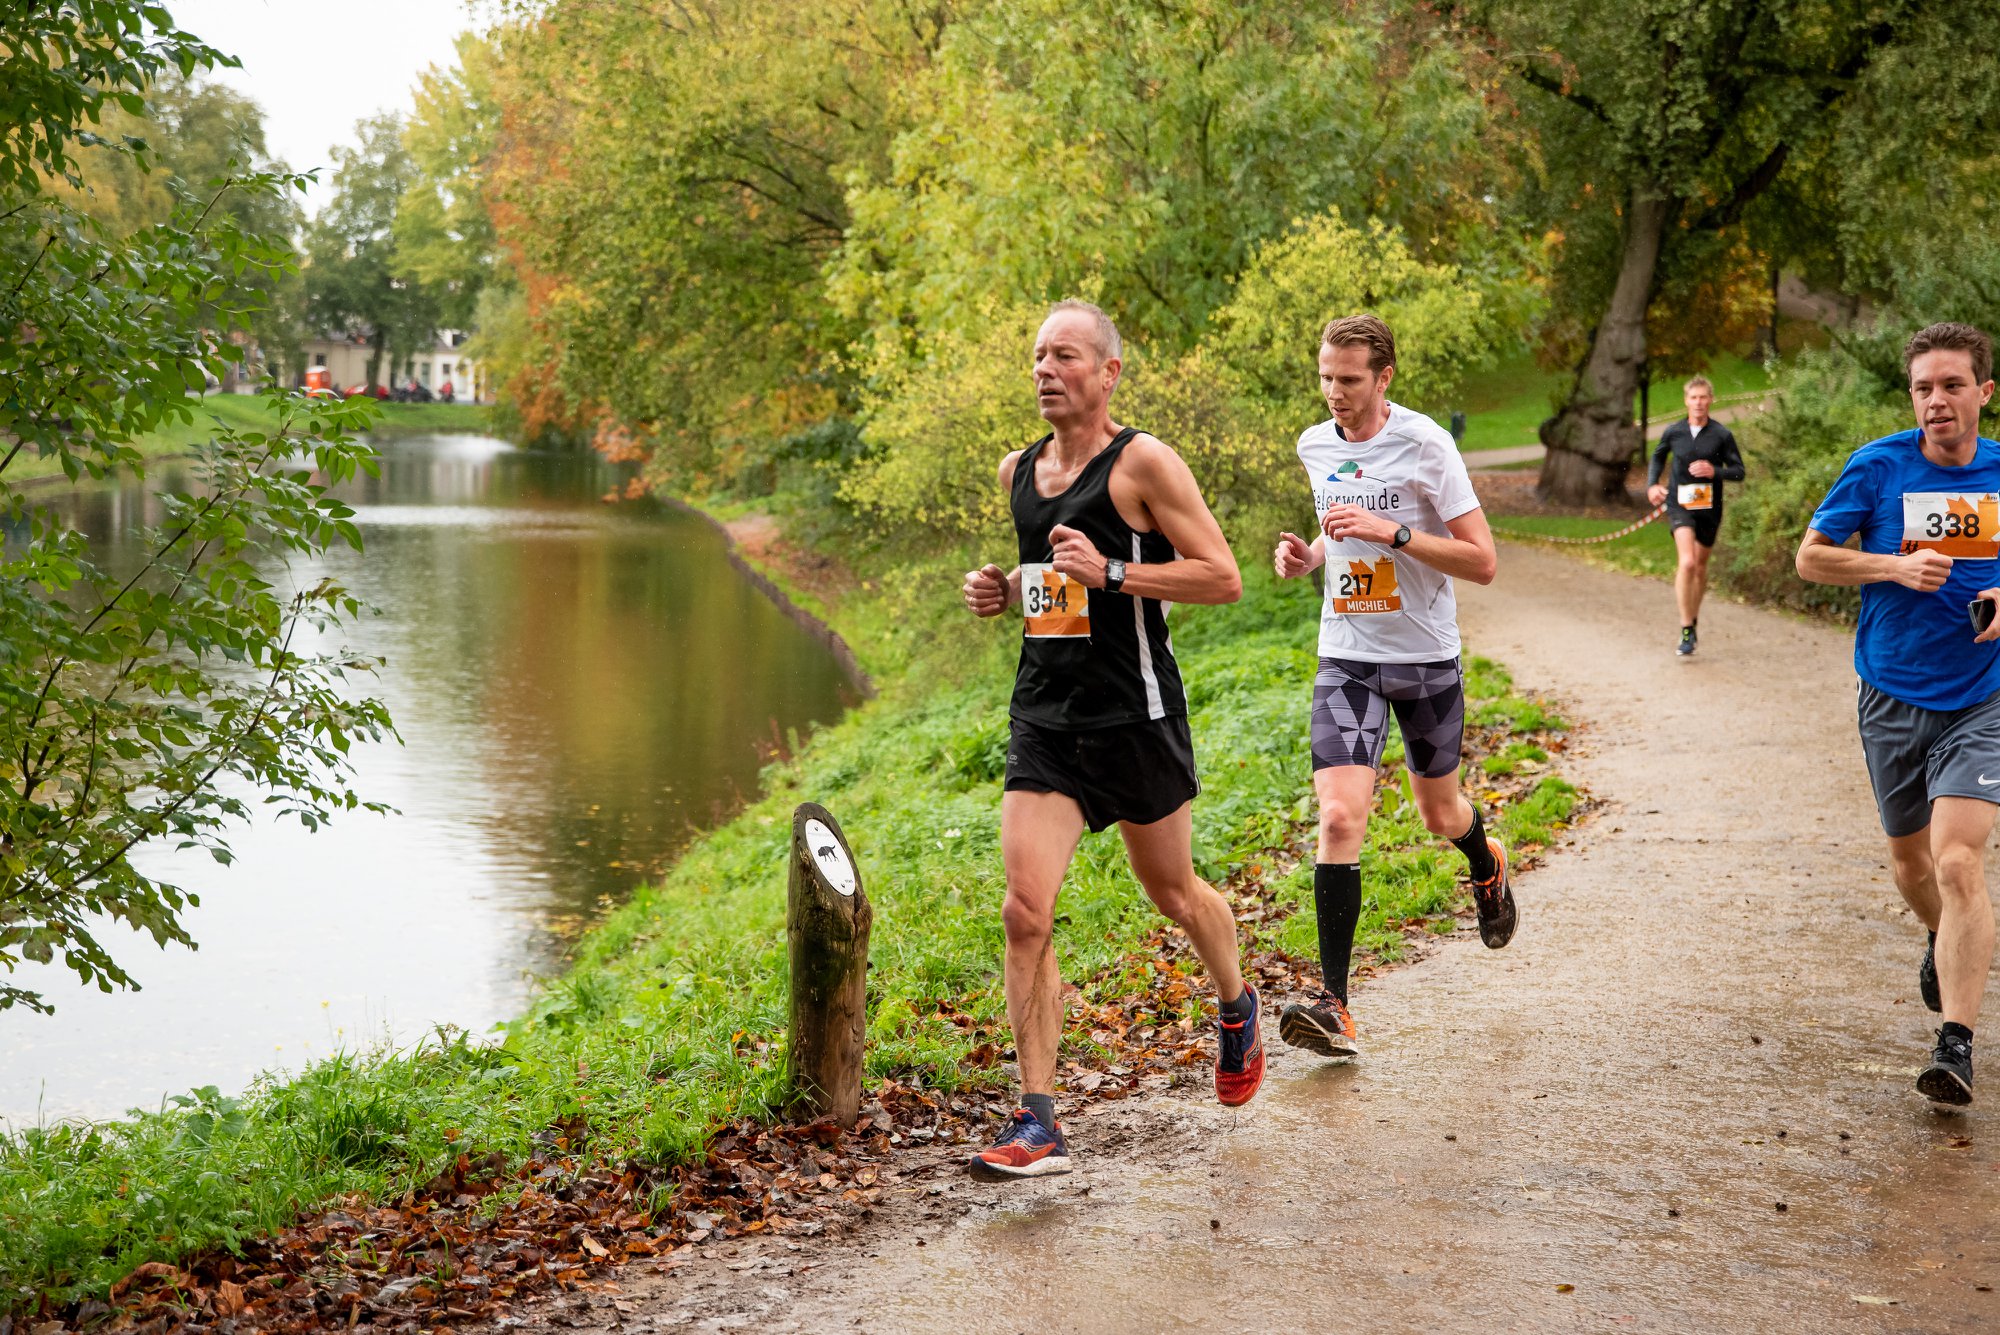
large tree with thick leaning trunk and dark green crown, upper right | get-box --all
[1448,0,1994,504]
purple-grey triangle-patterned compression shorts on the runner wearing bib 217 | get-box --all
[1312,658,1466,779]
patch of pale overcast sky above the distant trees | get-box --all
[164,0,486,212]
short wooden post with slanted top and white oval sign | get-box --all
[786,801,874,1127]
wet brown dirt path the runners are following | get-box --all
[586,546,2000,1333]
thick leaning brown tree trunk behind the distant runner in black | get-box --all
[1534,190,1670,506]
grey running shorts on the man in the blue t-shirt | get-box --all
[1856,681,2000,839]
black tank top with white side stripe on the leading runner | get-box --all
[1012,426,1188,729]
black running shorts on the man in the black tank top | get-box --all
[1006,713,1202,833]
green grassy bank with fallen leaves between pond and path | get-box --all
[0,543,1574,1319]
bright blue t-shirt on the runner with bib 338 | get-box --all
[1812,428,2000,709]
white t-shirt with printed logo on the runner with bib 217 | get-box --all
[1298,404,1480,664]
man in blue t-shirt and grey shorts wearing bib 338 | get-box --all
[1798,324,2000,1103]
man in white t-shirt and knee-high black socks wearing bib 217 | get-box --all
[1274,316,1516,1057]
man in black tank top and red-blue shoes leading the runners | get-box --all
[964,302,1264,1181]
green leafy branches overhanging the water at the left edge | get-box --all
[0,0,388,1009]
